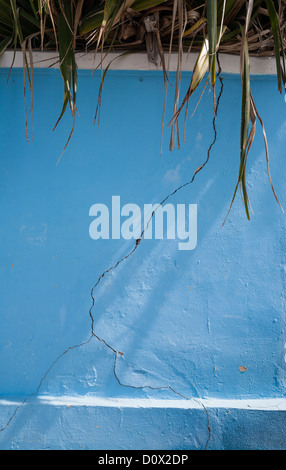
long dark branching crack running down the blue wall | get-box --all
[0,57,224,450]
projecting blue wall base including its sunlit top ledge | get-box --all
[0,397,286,450]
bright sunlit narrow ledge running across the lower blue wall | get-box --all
[0,395,286,411]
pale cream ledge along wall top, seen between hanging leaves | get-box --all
[0,51,276,75]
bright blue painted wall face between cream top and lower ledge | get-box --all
[0,64,286,448]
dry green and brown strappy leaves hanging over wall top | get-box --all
[0,0,286,219]
